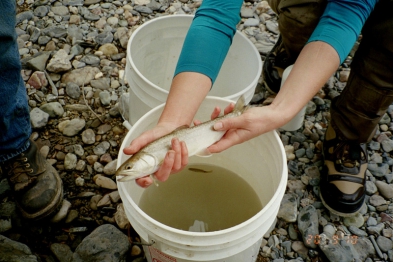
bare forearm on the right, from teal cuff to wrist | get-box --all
[271,41,340,124]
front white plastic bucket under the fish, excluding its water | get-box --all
[117,97,288,262]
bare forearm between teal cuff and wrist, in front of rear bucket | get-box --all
[158,72,212,127]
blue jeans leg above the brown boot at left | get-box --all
[0,0,31,162]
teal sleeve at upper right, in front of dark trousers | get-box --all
[308,0,378,63]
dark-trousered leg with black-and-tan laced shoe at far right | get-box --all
[321,0,393,215]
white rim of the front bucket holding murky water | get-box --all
[116,96,288,238]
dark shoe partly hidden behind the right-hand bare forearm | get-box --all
[262,35,295,94]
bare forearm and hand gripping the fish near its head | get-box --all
[124,72,212,187]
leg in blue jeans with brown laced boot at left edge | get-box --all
[0,0,63,219]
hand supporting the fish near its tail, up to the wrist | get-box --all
[208,106,287,153]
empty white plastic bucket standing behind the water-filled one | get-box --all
[125,15,262,125]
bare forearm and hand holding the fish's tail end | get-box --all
[209,41,340,153]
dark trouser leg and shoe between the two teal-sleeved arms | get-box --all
[262,0,327,93]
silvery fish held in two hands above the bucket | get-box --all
[116,96,249,182]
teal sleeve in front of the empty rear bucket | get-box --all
[175,0,243,83]
